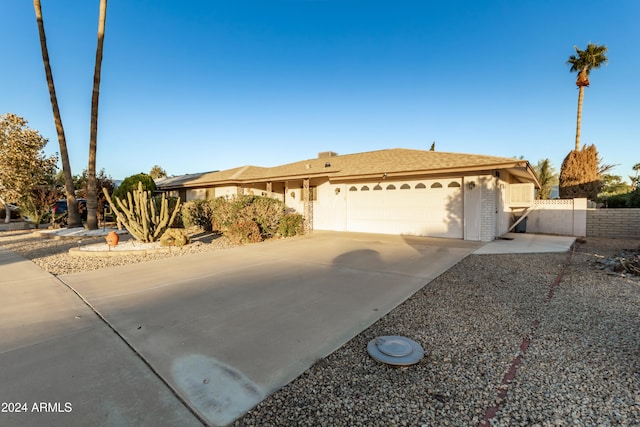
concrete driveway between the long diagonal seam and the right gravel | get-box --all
[0,232,483,425]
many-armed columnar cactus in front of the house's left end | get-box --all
[103,182,180,243]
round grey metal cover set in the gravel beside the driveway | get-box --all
[367,335,424,366]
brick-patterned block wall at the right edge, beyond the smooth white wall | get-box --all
[587,209,640,239]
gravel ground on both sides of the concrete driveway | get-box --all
[0,231,640,427]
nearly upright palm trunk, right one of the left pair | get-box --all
[87,0,107,230]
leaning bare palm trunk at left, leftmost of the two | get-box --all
[33,0,82,227]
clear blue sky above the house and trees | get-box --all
[0,0,640,179]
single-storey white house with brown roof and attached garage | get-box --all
[156,148,539,241]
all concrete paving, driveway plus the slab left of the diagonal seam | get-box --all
[0,232,568,426]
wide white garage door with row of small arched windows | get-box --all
[347,178,463,239]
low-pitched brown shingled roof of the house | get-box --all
[158,148,535,187]
